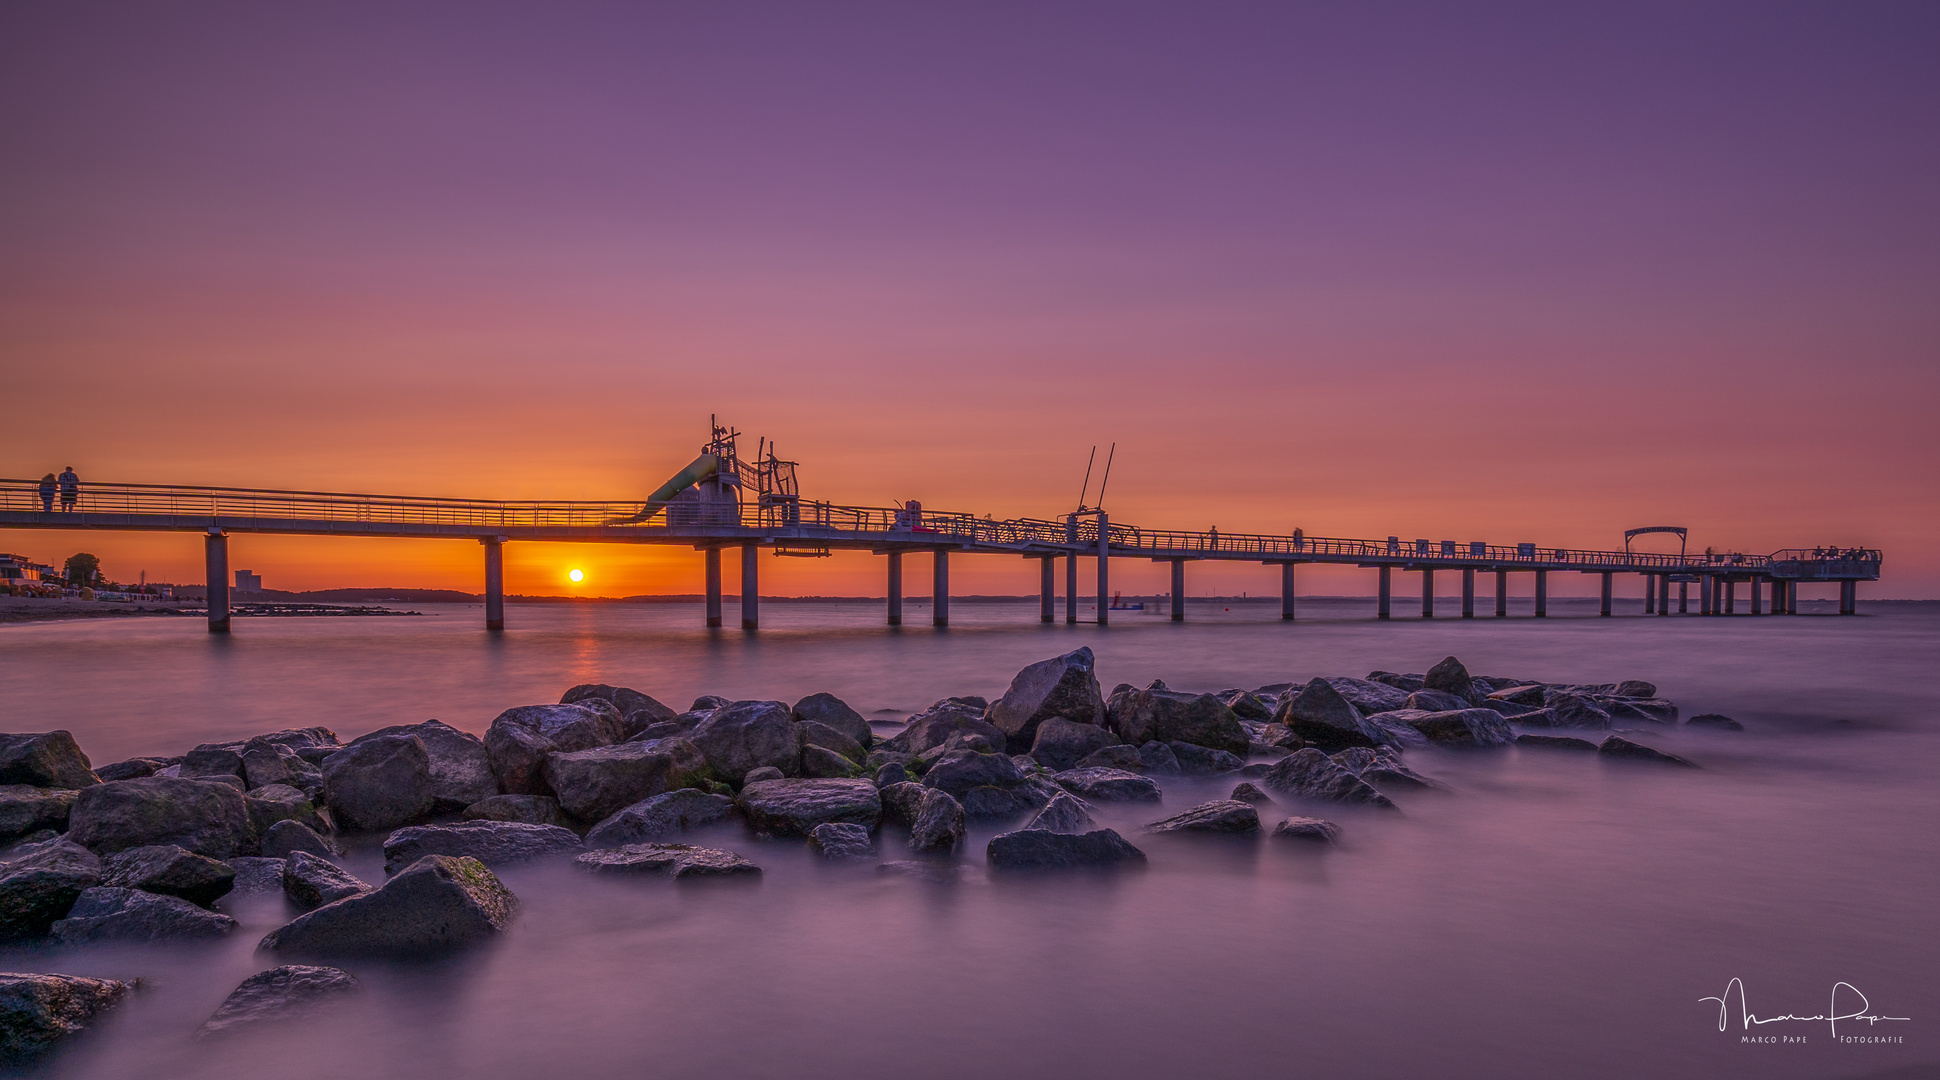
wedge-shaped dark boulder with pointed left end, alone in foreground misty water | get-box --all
[262,853,527,956]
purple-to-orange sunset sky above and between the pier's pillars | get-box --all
[0,4,1940,597]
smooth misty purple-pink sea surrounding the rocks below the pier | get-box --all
[0,601,1940,1080]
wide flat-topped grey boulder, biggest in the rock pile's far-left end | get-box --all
[68,776,256,859]
